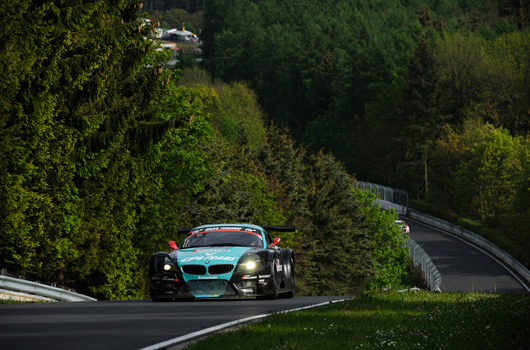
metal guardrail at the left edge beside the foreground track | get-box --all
[0,269,97,301]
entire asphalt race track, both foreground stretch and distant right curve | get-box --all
[0,219,528,350]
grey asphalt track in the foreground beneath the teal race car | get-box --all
[0,297,345,350]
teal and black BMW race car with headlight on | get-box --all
[149,224,296,301]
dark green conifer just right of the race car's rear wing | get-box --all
[299,152,373,295]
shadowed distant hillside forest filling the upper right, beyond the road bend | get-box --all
[198,0,530,266]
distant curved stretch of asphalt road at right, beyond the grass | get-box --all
[404,218,529,293]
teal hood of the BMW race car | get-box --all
[176,247,253,265]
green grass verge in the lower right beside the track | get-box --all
[188,291,530,350]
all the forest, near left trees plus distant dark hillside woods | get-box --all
[0,0,530,299]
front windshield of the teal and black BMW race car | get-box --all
[181,228,263,248]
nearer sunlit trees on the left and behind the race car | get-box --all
[0,0,406,299]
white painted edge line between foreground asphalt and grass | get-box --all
[140,299,349,350]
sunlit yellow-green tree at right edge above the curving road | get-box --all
[431,120,530,264]
